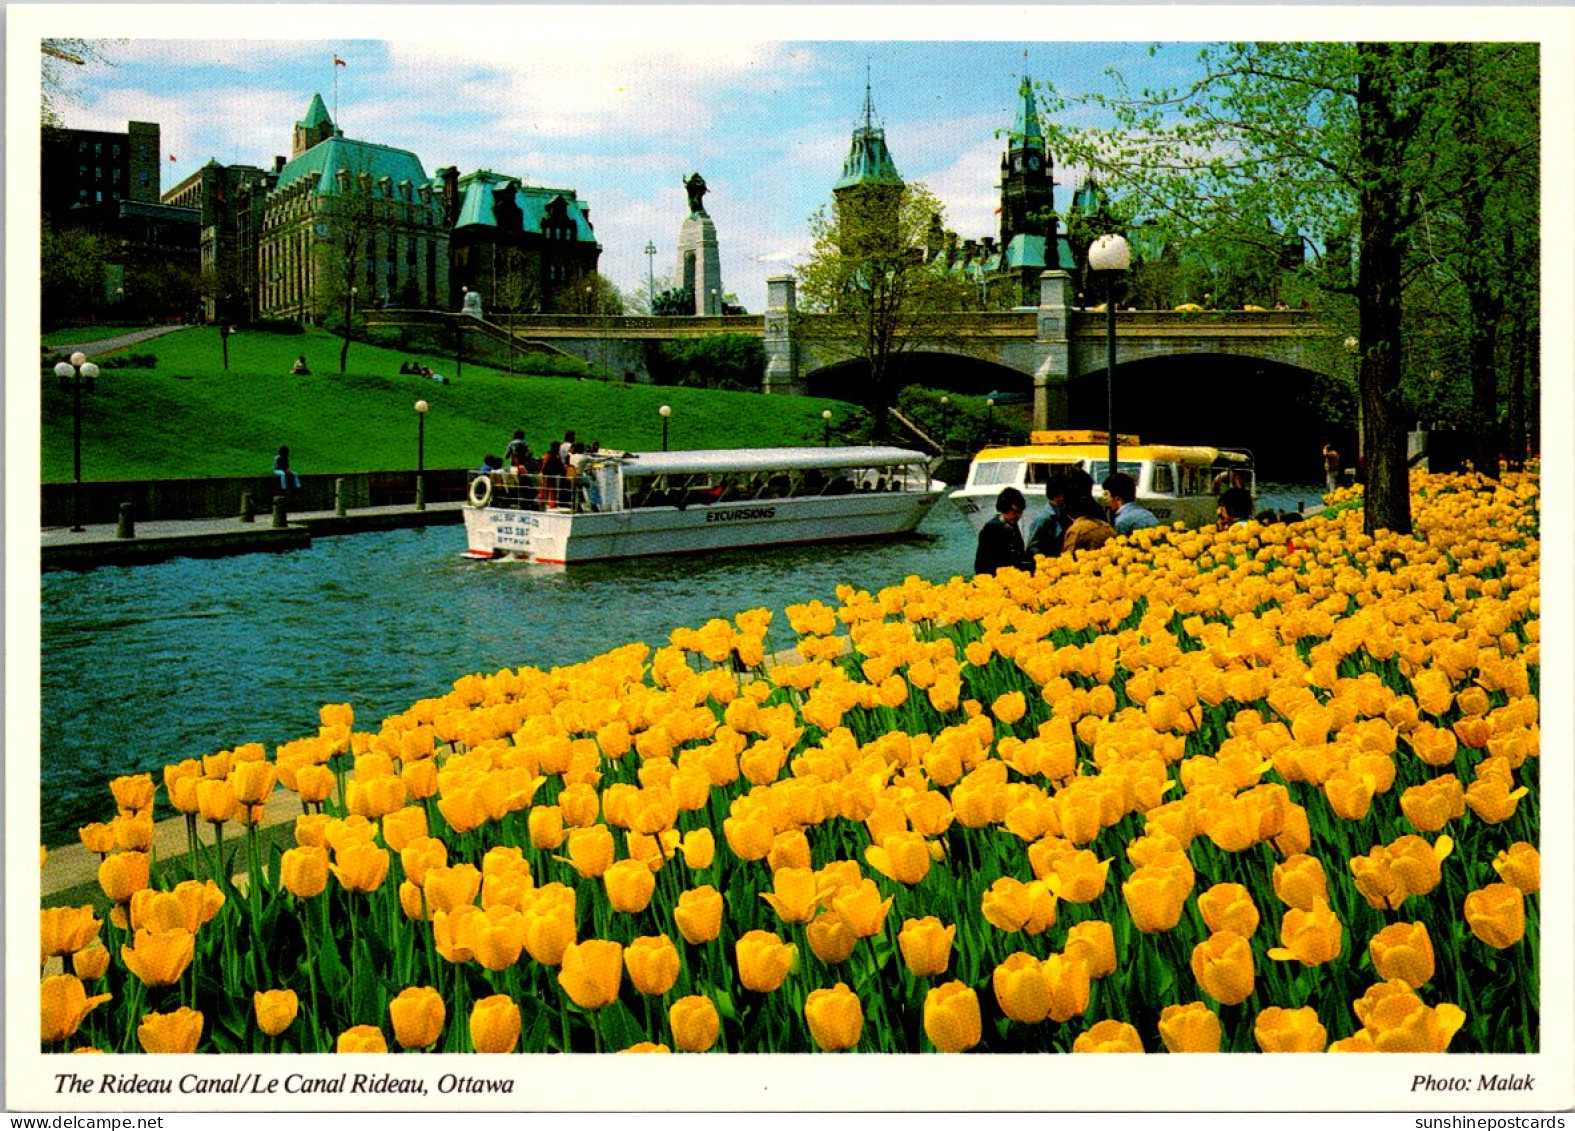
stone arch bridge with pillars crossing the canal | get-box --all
[367,271,1336,428]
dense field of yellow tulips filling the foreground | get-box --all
[41,474,1540,1052]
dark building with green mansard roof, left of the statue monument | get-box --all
[436,165,602,313]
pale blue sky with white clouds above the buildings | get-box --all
[43,31,1195,312]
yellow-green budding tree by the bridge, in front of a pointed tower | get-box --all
[797,184,978,438]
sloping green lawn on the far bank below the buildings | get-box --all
[39,326,857,482]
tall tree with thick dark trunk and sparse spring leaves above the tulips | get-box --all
[1047,43,1537,532]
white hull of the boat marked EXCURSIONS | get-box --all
[465,484,943,564]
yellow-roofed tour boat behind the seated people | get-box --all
[950,432,1257,531]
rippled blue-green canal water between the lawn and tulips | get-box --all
[41,484,1320,844]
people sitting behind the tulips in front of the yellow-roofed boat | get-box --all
[973,468,1252,573]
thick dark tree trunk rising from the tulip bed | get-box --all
[1356,44,1411,534]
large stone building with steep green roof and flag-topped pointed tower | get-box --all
[257,96,449,321]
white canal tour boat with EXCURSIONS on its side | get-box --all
[465,447,947,564]
